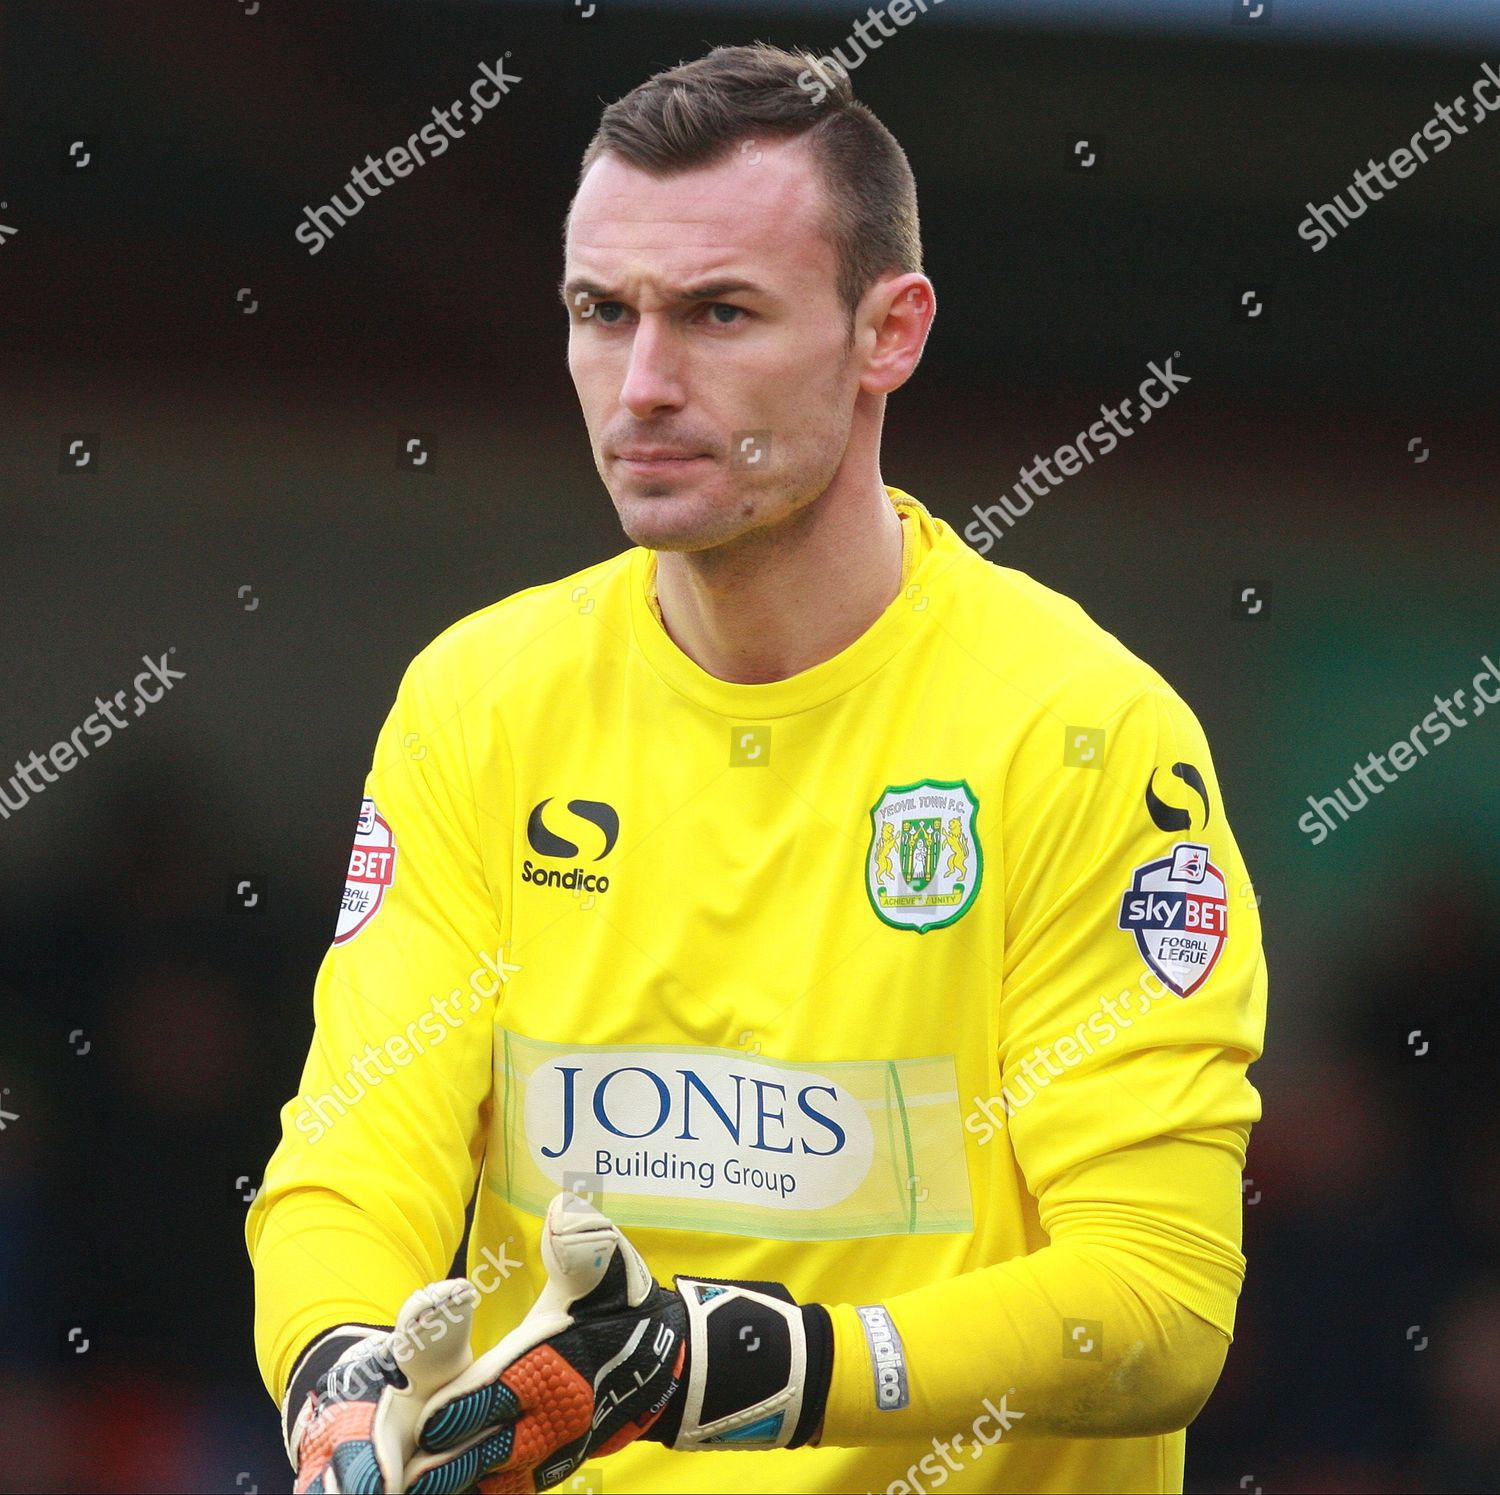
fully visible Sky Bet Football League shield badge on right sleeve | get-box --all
[1119,841,1229,997]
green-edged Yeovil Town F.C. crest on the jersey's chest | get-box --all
[866,778,984,934]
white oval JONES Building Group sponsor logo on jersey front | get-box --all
[525,1048,875,1210]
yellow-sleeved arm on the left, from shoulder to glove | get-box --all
[246,640,503,1457]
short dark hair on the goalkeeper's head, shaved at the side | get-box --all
[569,42,923,328]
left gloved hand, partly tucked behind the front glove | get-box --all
[288,1279,479,1495]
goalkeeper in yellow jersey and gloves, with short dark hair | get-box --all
[249,46,1265,1492]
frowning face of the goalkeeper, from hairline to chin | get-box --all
[564,139,860,550]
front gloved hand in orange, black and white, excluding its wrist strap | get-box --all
[404,1194,687,1495]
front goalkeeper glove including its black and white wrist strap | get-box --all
[405,1194,833,1495]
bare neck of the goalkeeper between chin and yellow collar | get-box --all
[657,478,902,685]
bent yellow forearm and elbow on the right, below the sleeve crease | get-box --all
[821,1128,1244,1447]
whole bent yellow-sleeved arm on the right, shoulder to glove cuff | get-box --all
[824,687,1266,1444]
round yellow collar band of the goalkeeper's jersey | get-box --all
[630,484,938,721]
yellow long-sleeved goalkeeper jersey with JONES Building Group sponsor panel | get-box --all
[248,489,1266,1495]
